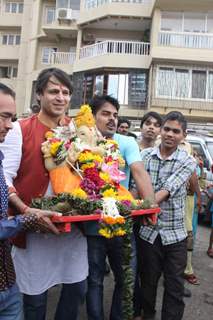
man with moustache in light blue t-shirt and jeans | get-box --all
[86,96,154,320]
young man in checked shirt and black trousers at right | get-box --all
[140,111,196,320]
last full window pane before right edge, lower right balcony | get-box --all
[192,70,206,99]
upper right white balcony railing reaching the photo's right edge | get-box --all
[158,31,213,49]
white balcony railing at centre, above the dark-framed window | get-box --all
[80,40,150,59]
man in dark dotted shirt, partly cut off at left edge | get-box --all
[0,83,58,320]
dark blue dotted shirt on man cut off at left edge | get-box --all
[0,151,36,291]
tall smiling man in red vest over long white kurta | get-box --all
[2,68,88,320]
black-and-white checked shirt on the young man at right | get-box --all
[140,147,196,245]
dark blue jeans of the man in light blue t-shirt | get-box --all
[87,236,123,320]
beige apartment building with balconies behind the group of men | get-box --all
[0,0,213,122]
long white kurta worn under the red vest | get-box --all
[0,122,88,295]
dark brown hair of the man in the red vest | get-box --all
[35,68,73,94]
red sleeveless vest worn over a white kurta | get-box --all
[12,115,70,248]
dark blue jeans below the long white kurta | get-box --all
[24,280,87,320]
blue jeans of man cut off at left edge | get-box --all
[0,284,23,320]
